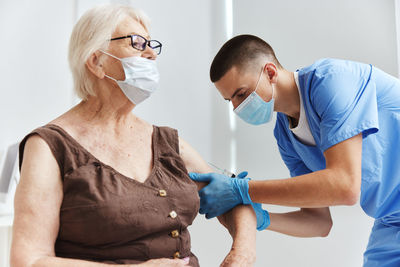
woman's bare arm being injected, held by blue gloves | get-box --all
[179,138,257,266]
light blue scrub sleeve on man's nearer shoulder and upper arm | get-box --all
[310,71,379,151]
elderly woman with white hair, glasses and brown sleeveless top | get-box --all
[11,5,256,266]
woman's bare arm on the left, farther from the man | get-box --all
[11,135,63,266]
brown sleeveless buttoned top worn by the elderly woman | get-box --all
[20,124,199,267]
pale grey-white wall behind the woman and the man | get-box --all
[0,0,400,267]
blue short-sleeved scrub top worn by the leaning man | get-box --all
[274,59,400,218]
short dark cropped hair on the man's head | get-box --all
[210,34,282,83]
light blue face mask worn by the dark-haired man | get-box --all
[234,67,275,125]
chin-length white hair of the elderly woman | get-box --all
[68,4,149,100]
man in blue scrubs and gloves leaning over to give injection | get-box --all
[190,35,400,267]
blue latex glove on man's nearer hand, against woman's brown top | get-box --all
[189,172,251,219]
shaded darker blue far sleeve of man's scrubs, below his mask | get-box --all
[274,116,311,177]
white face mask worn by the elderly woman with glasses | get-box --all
[100,50,160,105]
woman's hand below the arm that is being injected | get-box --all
[220,248,256,267]
